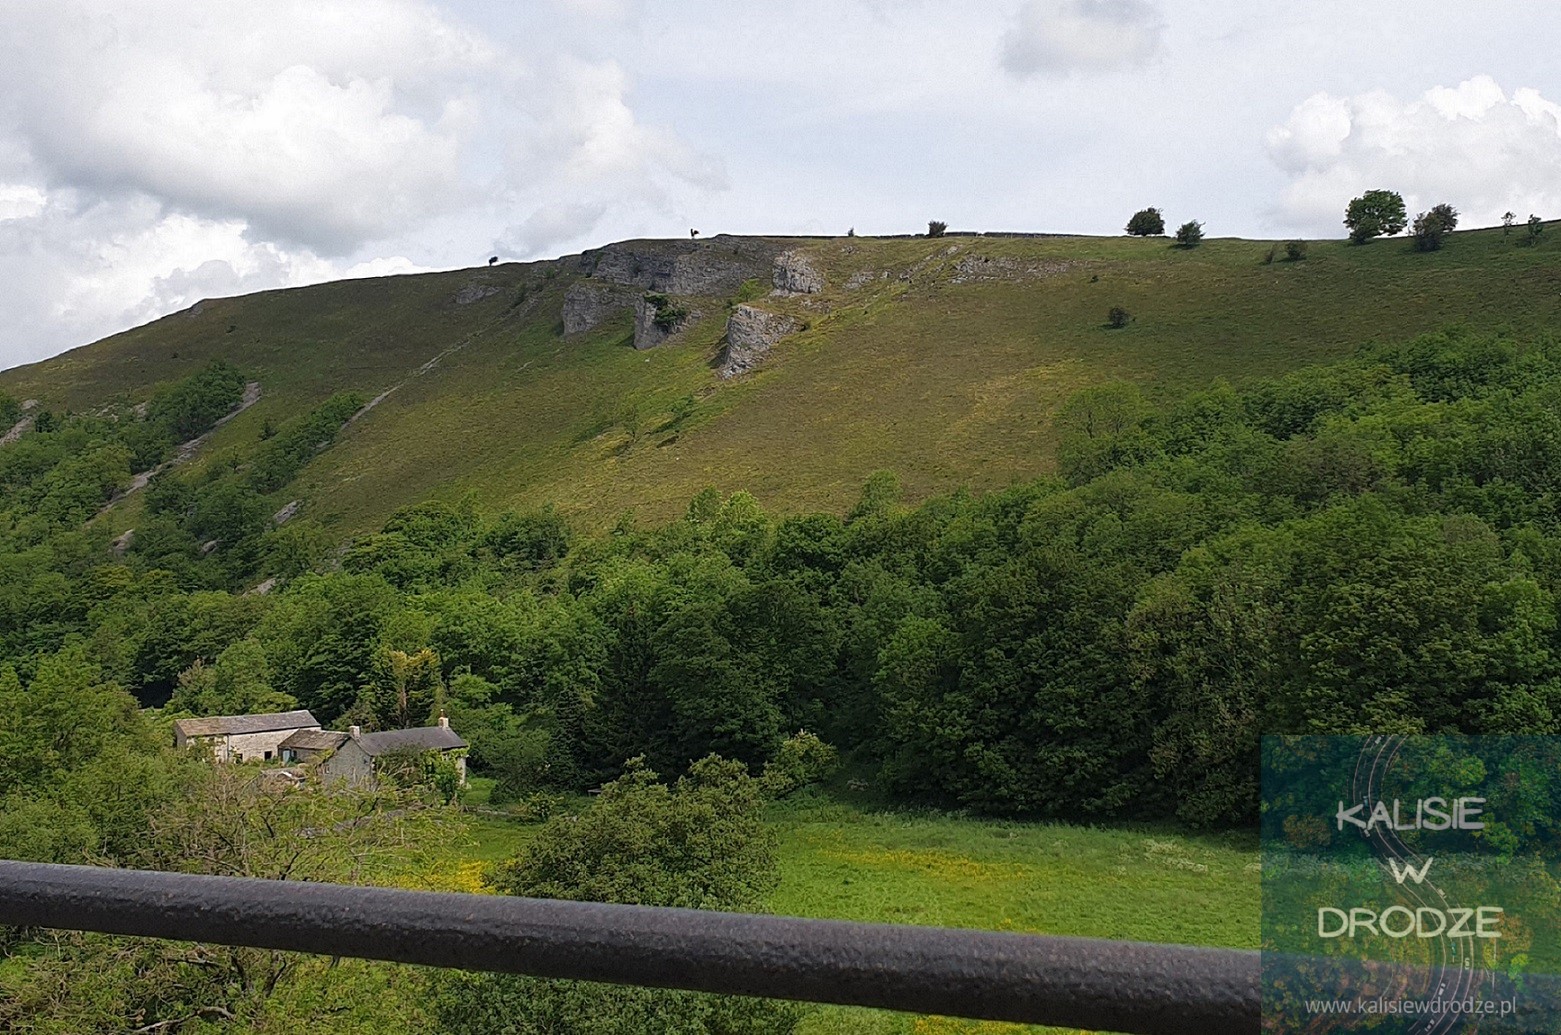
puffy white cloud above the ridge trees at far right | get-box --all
[1268,75,1561,236]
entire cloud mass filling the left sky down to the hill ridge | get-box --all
[0,0,724,368]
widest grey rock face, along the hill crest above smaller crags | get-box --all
[582,234,781,295]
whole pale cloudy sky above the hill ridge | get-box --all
[0,0,1561,367]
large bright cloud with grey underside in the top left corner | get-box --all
[0,0,496,254]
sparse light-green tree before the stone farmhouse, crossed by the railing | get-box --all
[9,762,437,1035]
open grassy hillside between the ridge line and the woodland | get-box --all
[0,226,1561,532]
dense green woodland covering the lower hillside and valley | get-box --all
[0,329,1561,1030]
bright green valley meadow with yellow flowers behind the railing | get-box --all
[431,798,1258,1035]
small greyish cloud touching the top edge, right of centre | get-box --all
[1002,0,1163,78]
